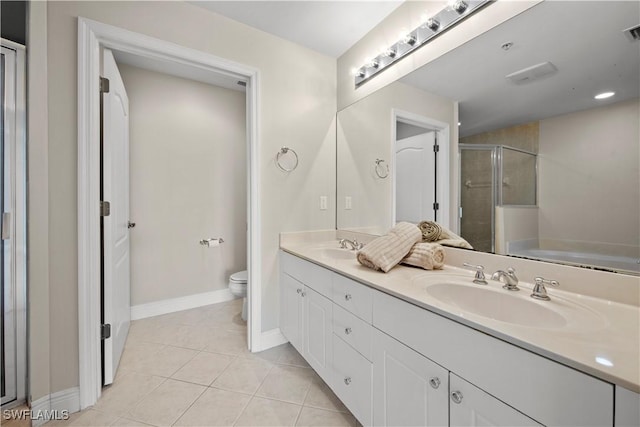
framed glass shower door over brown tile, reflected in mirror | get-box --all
[459,144,497,252]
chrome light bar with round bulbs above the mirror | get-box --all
[353,0,494,87]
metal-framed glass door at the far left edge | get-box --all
[0,39,27,407]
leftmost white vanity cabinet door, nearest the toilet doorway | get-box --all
[280,273,304,354]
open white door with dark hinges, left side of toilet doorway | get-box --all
[102,49,131,385]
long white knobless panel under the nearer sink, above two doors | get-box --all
[372,290,613,426]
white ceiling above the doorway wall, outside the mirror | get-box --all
[189,0,404,58]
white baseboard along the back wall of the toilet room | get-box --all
[131,288,235,320]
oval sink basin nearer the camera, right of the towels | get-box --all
[427,283,604,330]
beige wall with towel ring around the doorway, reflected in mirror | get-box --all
[336,82,457,234]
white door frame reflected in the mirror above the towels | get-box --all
[390,108,451,228]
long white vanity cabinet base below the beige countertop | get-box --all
[280,252,616,427]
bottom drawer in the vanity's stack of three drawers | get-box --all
[332,334,373,426]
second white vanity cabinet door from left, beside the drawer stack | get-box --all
[302,287,333,382]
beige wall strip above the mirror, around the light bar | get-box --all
[337,0,541,110]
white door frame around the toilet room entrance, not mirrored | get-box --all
[78,17,263,409]
